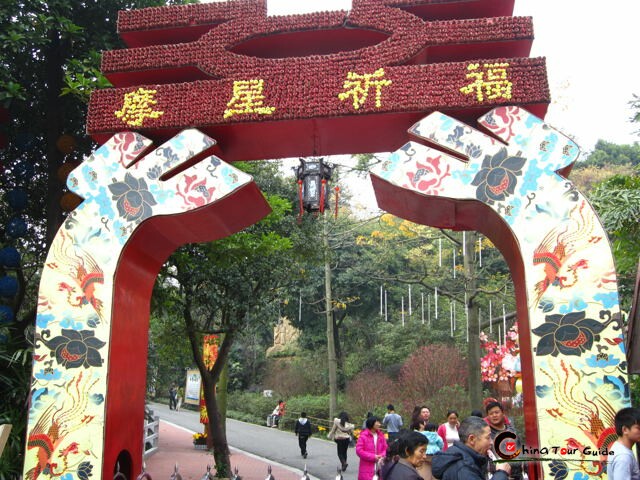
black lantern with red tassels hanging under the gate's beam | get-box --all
[296,158,333,213]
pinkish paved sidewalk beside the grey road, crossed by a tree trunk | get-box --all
[145,420,302,480]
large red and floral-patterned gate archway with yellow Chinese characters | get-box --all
[25,0,628,478]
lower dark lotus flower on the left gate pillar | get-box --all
[42,329,106,368]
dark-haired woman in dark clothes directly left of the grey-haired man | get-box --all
[381,431,428,480]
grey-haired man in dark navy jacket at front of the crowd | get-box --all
[432,417,511,480]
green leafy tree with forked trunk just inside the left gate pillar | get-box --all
[157,163,306,477]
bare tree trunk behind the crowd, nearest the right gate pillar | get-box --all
[464,231,482,408]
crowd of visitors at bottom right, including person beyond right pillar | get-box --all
[318,399,640,480]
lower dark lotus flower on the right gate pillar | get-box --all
[532,312,605,357]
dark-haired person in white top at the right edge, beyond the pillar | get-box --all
[607,408,640,480]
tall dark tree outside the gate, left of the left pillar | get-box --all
[0,0,191,476]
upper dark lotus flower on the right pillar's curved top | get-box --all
[471,148,527,205]
